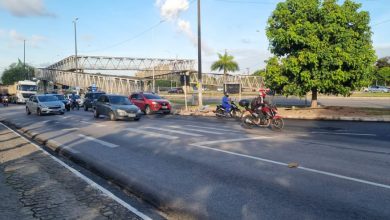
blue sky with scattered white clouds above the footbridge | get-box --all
[0,0,390,74]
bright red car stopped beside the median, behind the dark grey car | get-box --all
[129,92,172,115]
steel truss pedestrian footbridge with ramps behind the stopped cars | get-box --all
[36,56,263,95]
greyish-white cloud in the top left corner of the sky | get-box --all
[0,0,54,17]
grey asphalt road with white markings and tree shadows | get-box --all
[0,106,390,219]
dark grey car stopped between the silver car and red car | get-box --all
[93,95,142,121]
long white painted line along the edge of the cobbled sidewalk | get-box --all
[0,122,152,220]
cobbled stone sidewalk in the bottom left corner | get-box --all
[0,124,140,220]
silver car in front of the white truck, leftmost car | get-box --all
[26,95,65,115]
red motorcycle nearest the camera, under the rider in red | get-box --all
[239,100,284,130]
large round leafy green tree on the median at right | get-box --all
[266,0,376,107]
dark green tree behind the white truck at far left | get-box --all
[1,60,34,85]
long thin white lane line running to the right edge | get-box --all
[190,144,390,190]
